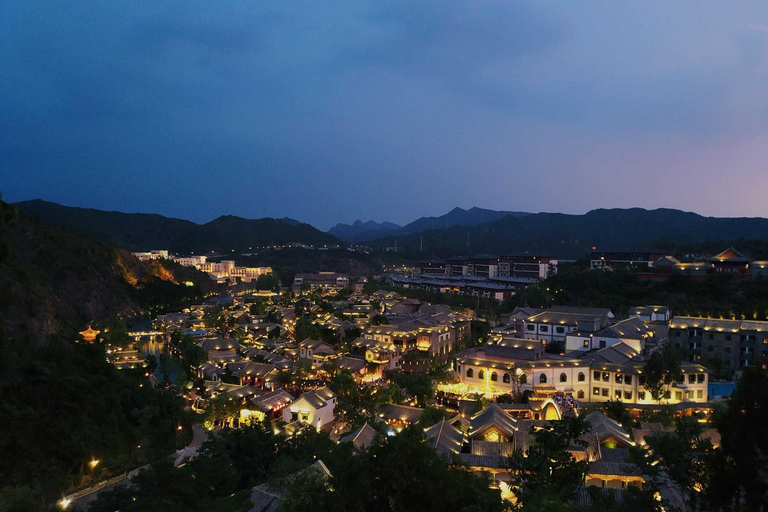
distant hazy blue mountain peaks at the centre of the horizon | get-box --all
[328,206,531,243]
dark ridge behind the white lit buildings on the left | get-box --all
[14,200,339,254]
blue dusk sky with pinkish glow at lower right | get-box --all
[0,0,768,229]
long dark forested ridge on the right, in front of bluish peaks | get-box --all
[371,208,768,258]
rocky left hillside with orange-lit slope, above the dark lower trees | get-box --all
[0,201,213,341]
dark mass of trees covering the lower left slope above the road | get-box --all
[0,335,187,504]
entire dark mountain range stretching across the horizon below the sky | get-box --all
[16,200,768,258]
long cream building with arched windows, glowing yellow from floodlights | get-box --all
[456,337,709,404]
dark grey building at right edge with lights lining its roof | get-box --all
[669,316,768,373]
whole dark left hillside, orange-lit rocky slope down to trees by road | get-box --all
[0,196,207,504]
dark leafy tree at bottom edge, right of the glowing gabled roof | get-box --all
[509,416,590,511]
